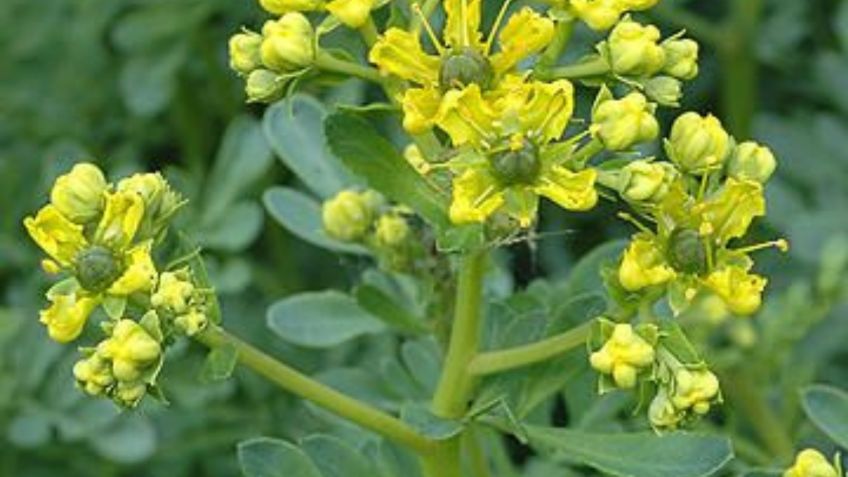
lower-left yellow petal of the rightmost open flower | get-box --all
[618,234,677,291]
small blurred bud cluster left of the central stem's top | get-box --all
[321,190,415,269]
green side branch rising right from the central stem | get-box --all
[468,322,592,376]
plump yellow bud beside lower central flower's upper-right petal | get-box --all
[592,90,660,151]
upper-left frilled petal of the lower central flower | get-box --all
[436,84,498,146]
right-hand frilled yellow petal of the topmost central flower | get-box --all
[492,7,554,73]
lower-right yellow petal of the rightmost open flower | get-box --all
[705,265,768,316]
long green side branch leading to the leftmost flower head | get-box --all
[195,327,435,456]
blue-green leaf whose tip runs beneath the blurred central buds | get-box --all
[262,187,368,255]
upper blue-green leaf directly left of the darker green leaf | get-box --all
[263,95,356,198]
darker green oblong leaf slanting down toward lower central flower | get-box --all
[326,112,451,229]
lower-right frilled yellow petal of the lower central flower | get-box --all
[534,165,598,211]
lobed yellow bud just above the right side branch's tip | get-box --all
[589,324,654,389]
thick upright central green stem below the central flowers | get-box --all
[433,251,487,419]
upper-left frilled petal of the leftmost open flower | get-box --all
[24,205,88,267]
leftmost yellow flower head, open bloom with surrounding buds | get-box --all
[24,163,210,406]
